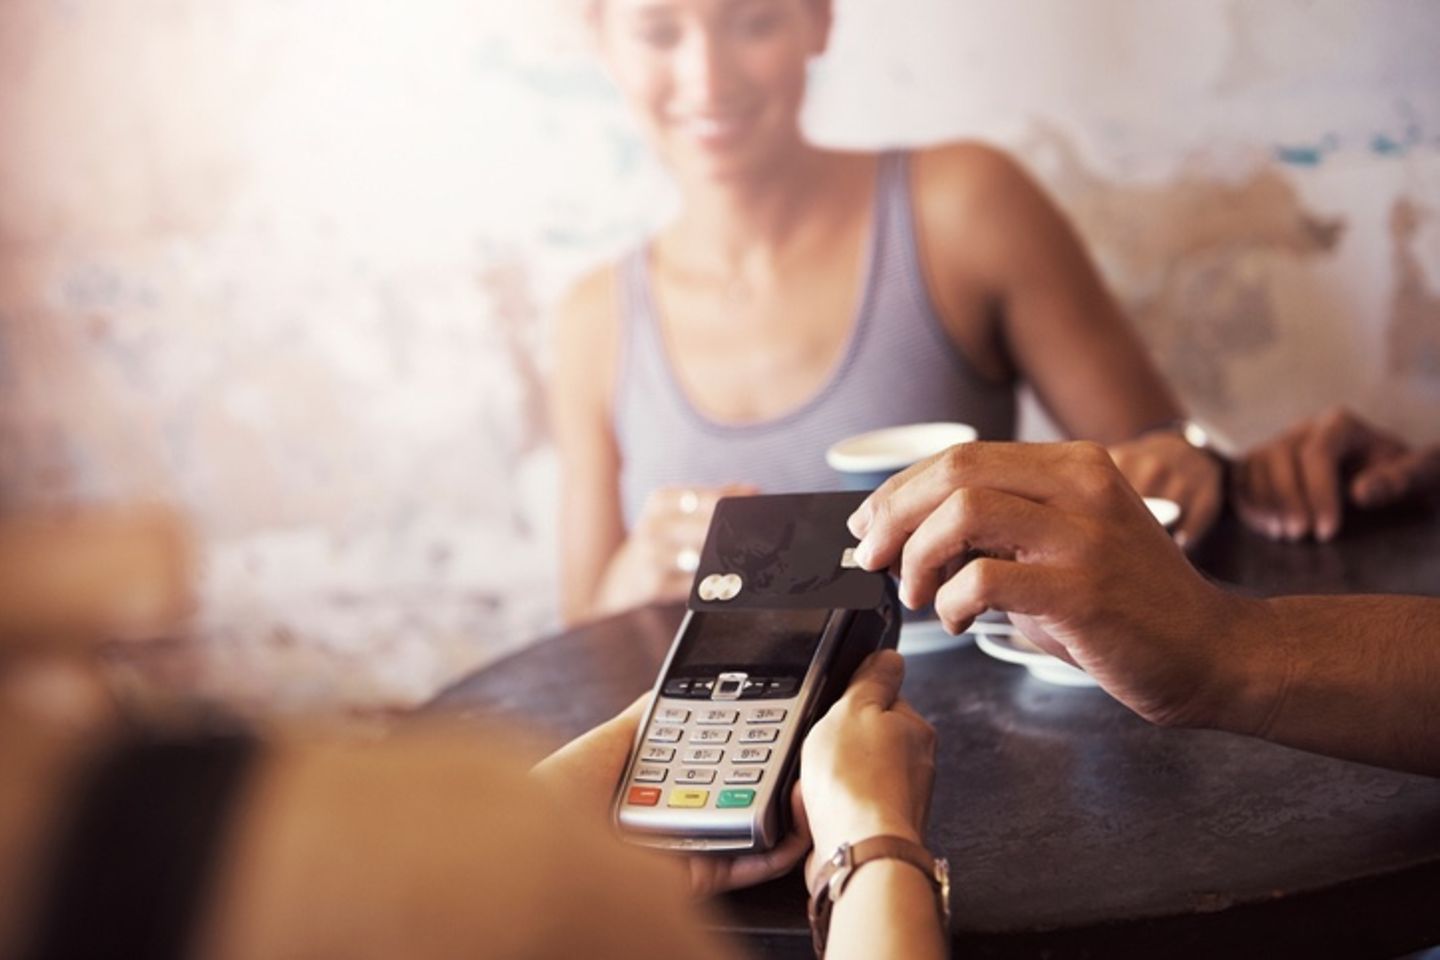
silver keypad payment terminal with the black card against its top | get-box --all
[613,492,900,853]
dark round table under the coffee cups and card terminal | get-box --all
[432,502,1440,957]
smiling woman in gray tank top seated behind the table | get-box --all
[553,0,1220,622]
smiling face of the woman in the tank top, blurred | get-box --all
[593,0,829,180]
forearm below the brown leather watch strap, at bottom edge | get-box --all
[825,859,949,960]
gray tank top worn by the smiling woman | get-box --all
[612,151,1015,527]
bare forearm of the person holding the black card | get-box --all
[1214,596,1440,776]
